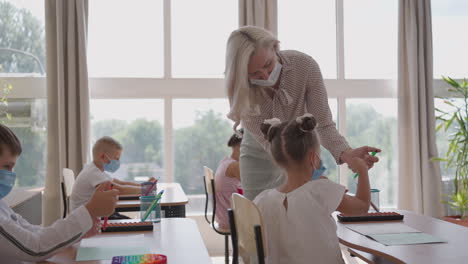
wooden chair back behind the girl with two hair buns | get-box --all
[228,193,267,264]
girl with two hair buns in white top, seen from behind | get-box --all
[254,114,370,264]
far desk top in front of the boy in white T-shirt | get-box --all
[117,183,188,208]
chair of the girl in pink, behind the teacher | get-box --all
[203,166,231,264]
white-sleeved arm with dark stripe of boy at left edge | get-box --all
[0,182,118,261]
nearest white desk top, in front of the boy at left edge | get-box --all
[40,218,211,264]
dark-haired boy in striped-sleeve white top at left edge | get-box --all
[0,124,118,263]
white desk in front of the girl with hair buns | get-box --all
[333,210,468,264]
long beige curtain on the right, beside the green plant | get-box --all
[398,0,442,217]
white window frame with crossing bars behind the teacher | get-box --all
[5,0,458,198]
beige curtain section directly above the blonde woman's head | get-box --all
[239,0,278,36]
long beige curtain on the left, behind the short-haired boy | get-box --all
[42,0,89,226]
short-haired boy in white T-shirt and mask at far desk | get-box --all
[70,137,153,210]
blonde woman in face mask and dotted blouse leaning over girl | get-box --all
[225,26,380,200]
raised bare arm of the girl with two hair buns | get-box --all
[337,158,370,214]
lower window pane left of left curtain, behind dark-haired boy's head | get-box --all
[0,99,47,187]
